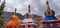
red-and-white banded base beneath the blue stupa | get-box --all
[42,20,60,28]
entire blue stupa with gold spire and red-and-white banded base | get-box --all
[42,0,60,28]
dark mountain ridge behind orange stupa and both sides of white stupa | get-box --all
[2,11,42,21]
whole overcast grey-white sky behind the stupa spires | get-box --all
[1,0,60,16]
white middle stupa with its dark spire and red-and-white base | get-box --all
[21,5,38,28]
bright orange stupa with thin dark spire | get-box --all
[4,8,19,28]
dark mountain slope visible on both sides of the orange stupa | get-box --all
[2,11,24,21]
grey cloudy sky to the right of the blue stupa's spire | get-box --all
[50,0,60,15]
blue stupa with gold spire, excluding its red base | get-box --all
[44,0,56,20]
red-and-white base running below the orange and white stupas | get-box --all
[4,22,37,28]
